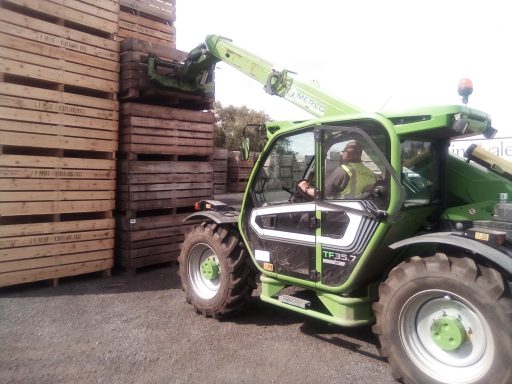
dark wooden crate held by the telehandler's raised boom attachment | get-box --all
[120,39,214,110]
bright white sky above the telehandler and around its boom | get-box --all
[175,0,512,137]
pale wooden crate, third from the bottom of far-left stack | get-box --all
[0,82,119,153]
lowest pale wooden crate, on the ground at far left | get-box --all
[0,215,114,287]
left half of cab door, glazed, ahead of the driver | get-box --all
[241,127,317,282]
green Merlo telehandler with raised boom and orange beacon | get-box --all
[148,35,512,384]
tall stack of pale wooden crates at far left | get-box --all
[0,0,119,286]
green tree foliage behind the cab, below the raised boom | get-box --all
[214,101,271,152]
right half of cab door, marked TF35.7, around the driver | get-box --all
[316,124,399,287]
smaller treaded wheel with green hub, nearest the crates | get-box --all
[179,223,256,318]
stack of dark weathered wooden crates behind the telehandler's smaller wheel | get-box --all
[116,0,214,273]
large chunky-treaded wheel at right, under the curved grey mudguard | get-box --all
[373,253,512,384]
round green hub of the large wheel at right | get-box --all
[430,315,467,351]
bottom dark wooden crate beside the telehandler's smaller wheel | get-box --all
[116,212,197,273]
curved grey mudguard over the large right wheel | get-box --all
[389,232,512,274]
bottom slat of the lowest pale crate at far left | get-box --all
[0,258,114,287]
